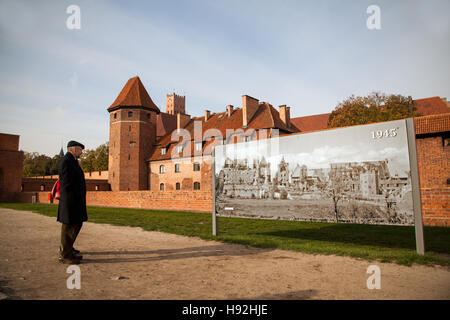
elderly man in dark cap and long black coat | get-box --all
[57,141,87,264]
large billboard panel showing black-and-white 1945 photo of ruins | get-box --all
[214,120,414,225]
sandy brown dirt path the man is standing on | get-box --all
[0,209,450,299]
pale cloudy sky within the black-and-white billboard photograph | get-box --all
[215,120,410,177]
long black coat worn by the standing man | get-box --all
[57,152,87,224]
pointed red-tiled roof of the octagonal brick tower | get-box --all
[108,76,160,113]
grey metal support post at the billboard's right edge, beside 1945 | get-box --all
[406,118,425,256]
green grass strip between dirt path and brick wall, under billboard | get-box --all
[0,203,450,266]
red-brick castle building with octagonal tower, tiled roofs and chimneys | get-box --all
[107,77,299,191]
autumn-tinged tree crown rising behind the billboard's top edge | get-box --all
[328,92,421,128]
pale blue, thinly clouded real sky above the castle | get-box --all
[0,0,450,156]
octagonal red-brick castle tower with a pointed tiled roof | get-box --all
[108,77,160,191]
